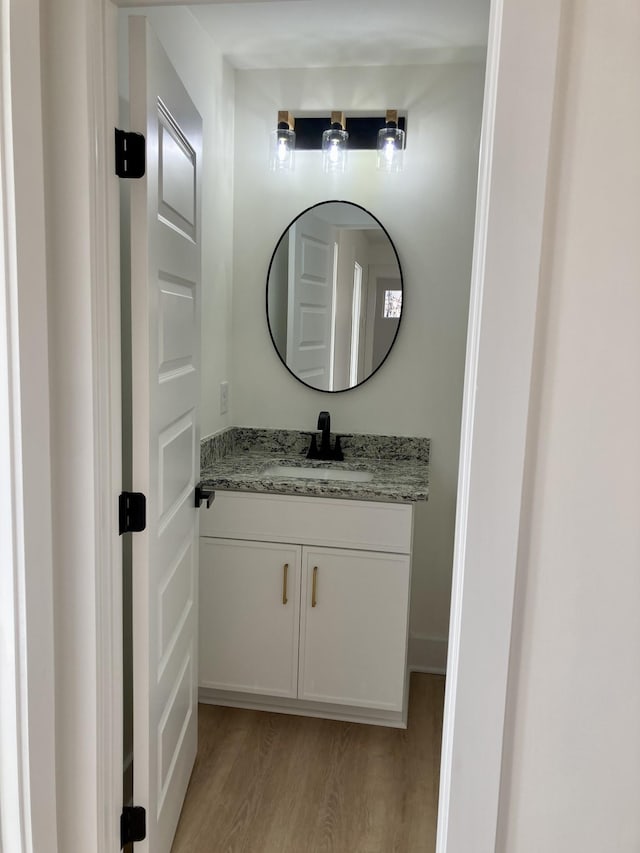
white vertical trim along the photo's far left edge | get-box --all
[0,0,57,853]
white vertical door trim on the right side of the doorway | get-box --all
[436,0,560,853]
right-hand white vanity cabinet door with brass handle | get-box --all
[298,548,410,711]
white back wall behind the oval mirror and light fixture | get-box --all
[231,64,484,666]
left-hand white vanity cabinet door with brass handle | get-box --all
[200,538,301,697]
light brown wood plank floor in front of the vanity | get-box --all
[172,673,444,853]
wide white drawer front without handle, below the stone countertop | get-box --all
[200,491,413,554]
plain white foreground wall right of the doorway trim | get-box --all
[498,0,640,853]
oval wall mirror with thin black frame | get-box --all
[267,201,402,391]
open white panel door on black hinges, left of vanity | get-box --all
[129,17,202,853]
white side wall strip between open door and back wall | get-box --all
[119,7,234,438]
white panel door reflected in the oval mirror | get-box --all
[287,213,334,391]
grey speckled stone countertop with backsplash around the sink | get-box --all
[201,427,430,503]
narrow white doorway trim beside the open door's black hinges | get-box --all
[87,0,123,851]
